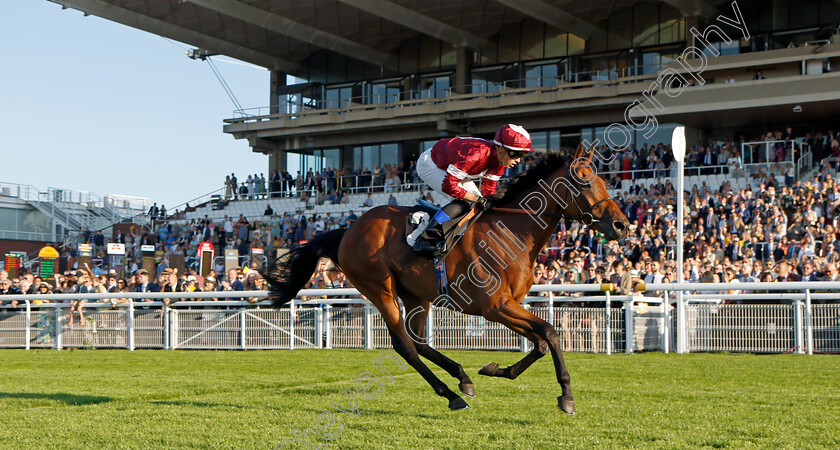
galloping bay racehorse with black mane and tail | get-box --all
[263,145,629,414]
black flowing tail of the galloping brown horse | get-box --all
[260,229,347,308]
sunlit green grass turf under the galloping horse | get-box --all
[0,350,840,449]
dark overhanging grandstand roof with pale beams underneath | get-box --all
[50,0,726,72]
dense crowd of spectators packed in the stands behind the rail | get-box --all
[0,129,840,310]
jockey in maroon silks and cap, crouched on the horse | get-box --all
[413,124,533,253]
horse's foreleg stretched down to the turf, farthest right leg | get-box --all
[484,302,575,414]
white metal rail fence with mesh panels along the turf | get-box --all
[0,282,840,354]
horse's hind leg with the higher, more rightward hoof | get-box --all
[400,291,475,397]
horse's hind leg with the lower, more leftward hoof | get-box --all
[356,279,469,411]
